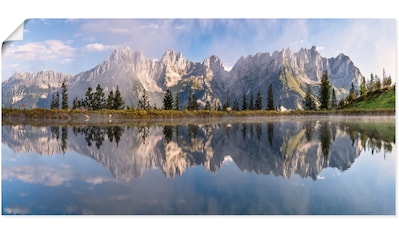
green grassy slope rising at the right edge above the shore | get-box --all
[344,89,395,110]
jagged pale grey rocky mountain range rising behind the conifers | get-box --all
[2,46,363,109]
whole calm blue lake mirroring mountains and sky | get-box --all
[1,116,397,215]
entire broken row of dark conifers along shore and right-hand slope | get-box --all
[50,68,392,111]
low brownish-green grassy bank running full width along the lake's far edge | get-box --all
[2,108,395,126]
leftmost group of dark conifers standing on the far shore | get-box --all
[50,81,125,110]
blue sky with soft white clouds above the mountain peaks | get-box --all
[2,18,397,81]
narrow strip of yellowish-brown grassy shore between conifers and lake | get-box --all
[2,108,395,124]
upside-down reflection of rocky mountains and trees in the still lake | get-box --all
[2,119,395,181]
